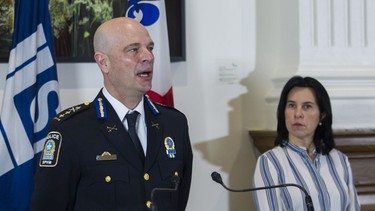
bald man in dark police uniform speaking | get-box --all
[31,17,193,211]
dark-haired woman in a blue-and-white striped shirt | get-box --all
[253,76,360,211]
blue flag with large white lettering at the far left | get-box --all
[0,0,60,211]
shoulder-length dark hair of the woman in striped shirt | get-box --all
[275,76,335,155]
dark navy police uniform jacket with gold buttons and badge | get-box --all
[31,92,193,211]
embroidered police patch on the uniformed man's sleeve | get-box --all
[39,131,62,167]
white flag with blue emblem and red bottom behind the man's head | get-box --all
[126,0,174,107]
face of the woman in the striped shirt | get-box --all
[285,87,320,146]
